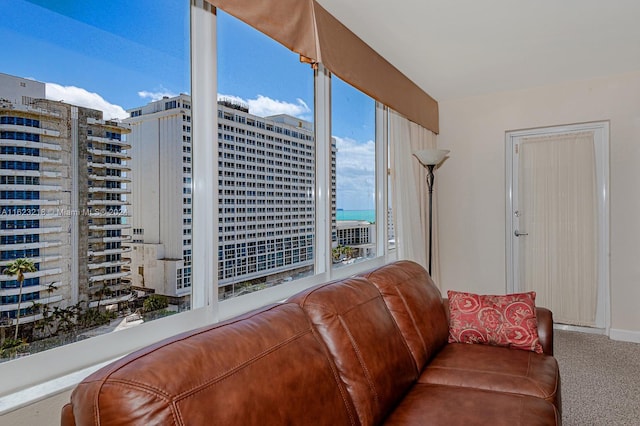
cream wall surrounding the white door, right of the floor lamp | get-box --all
[436,73,640,342]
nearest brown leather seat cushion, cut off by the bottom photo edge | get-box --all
[385,384,560,426]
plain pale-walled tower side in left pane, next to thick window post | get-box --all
[125,95,192,303]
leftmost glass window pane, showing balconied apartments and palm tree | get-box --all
[0,0,192,360]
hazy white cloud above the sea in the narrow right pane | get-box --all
[334,136,375,210]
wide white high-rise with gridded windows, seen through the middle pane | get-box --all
[218,100,318,298]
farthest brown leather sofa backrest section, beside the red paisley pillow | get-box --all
[361,260,449,370]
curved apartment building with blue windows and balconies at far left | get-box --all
[0,74,131,323]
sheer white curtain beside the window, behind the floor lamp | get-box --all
[389,111,440,285]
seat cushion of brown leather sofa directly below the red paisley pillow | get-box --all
[418,343,560,408]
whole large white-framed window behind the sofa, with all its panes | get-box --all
[0,0,398,406]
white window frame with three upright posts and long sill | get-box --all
[0,0,396,406]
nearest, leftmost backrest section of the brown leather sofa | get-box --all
[63,304,358,426]
